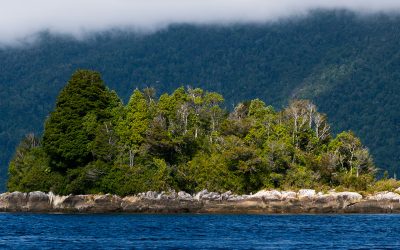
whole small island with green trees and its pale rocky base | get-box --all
[5,70,400,213]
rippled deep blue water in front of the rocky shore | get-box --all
[0,214,400,249]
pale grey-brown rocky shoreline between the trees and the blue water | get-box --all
[0,189,400,214]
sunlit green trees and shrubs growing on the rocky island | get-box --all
[8,70,376,195]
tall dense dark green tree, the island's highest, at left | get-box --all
[43,70,119,169]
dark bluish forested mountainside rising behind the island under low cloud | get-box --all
[0,12,400,189]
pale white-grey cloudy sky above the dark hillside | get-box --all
[0,0,400,45]
